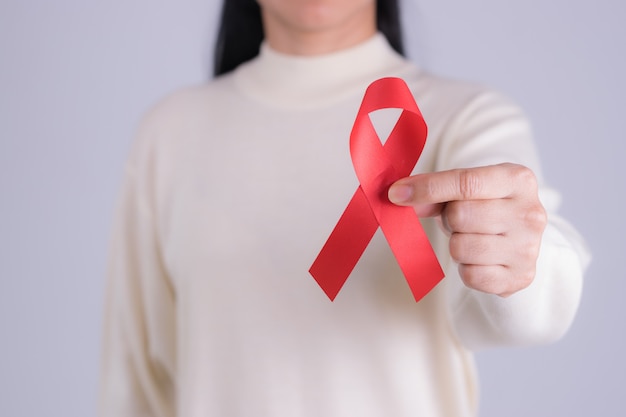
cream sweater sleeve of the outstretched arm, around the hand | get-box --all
[437,92,590,350]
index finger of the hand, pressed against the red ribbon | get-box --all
[388,163,537,206]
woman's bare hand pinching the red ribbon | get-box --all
[389,164,547,297]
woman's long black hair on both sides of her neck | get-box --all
[213,0,404,76]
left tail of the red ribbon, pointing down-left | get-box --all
[309,187,378,301]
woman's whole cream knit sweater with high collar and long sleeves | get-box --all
[100,35,587,417]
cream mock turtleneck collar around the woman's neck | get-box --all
[233,33,415,109]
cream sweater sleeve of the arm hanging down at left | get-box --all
[99,118,176,417]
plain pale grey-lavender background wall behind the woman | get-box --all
[0,0,626,417]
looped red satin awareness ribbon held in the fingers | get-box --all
[309,78,444,301]
